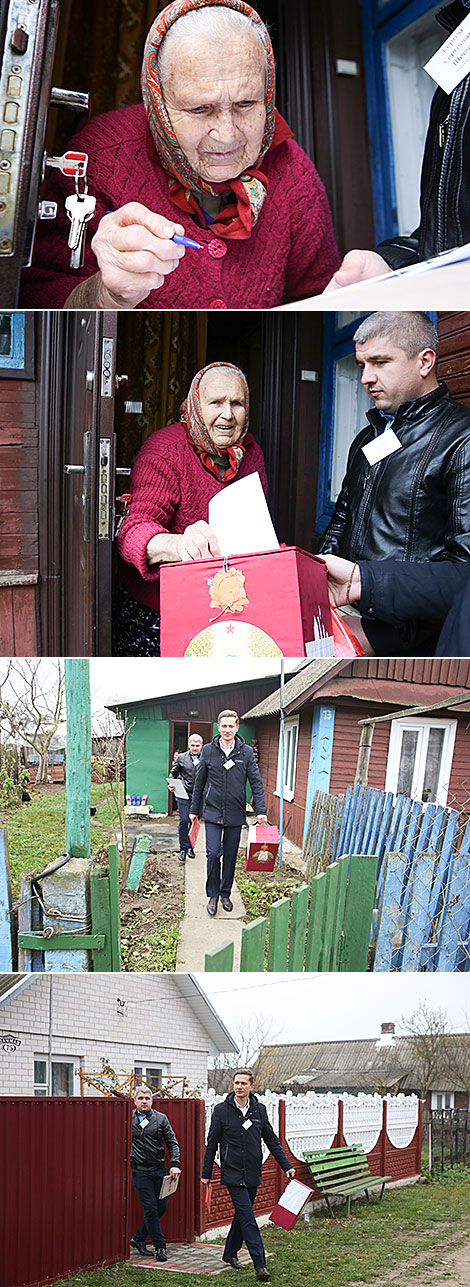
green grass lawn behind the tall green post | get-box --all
[0,782,116,898]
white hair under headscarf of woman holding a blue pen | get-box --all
[157,5,268,88]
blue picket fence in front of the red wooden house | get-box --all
[303,786,470,972]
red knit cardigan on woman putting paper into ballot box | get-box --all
[117,423,268,609]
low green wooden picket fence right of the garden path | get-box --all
[205,853,377,972]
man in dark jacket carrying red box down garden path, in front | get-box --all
[189,710,267,916]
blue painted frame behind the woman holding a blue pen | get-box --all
[359,0,444,242]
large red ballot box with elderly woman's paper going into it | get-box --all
[160,546,335,656]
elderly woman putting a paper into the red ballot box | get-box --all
[113,362,268,656]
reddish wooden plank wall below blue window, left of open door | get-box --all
[0,362,39,655]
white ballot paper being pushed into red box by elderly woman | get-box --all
[209,474,279,556]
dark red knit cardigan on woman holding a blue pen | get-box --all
[21,104,340,309]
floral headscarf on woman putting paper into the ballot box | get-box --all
[180,362,254,483]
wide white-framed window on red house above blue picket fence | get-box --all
[385,717,457,804]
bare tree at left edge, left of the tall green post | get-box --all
[0,658,64,782]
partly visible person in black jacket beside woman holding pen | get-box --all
[324,0,470,290]
